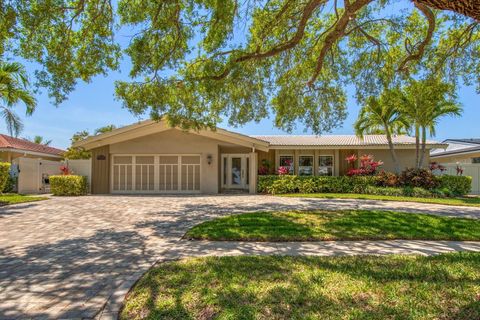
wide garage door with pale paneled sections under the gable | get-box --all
[112,155,200,193]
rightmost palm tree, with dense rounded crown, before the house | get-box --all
[401,78,462,168]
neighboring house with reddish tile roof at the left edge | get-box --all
[0,134,65,162]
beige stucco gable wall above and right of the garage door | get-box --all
[110,129,219,193]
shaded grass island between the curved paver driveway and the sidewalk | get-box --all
[184,210,480,241]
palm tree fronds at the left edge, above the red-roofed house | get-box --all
[0,62,36,137]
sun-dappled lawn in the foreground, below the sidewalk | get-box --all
[120,253,480,320]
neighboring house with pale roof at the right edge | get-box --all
[430,139,480,164]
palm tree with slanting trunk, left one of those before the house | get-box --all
[354,90,408,173]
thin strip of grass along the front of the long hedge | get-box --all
[277,193,480,207]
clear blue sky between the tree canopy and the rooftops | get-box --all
[7,1,480,149]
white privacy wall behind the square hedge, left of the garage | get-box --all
[13,158,92,193]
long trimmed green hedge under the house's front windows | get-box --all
[258,173,471,198]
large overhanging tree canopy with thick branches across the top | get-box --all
[0,0,480,132]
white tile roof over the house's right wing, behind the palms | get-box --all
[254,135,447,148]
